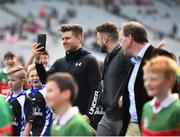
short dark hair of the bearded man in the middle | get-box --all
[96,22,119,42]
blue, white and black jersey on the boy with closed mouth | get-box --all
[7,91,34,136]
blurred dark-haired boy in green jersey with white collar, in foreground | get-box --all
[47,73,92,136]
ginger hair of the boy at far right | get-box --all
[143,56,178,88]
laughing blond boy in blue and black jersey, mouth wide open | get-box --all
[27,64,52,136]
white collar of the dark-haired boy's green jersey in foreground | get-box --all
[54,107,79,129]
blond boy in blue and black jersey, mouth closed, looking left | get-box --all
[7,66,33,136]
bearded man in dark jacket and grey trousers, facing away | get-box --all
[96,22,131,136]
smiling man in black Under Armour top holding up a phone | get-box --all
[33,24,102,128]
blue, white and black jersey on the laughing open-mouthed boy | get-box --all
[26,85,52,136]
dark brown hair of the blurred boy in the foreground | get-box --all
[47,72,78,102]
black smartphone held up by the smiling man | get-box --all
[37,34,46,52]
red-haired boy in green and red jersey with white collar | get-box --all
[142,56,180,136]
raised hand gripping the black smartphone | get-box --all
[32,43,43,64]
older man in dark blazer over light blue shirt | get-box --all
[117,22,172,136]
